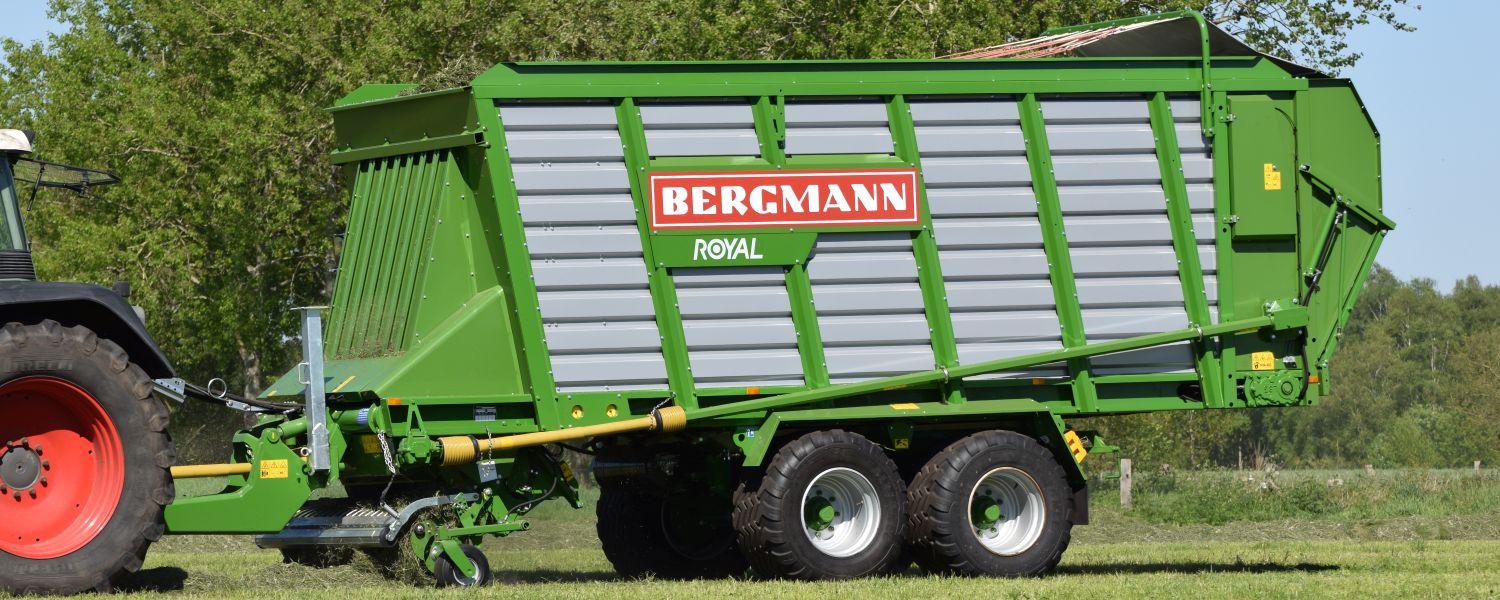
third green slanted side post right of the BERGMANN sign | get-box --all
[1151,92,1224,408]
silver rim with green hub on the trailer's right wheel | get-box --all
[969,467,1047,557]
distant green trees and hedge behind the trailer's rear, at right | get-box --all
[1103,267,1500,467]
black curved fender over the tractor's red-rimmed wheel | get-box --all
[0,282,177,380]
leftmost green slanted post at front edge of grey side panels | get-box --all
[476,99,561,431]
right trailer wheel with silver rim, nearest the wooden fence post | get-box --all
[906,431,1073,578]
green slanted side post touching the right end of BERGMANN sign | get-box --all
[887,95,965,402]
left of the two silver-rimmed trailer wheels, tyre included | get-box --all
[735,429,906,579]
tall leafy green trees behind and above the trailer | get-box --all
[0,0,1410,459]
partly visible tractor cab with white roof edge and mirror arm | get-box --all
[0,129,120,281]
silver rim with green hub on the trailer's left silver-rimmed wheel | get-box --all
[801,467,881,558]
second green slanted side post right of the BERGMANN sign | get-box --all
[1019,93,1100,413]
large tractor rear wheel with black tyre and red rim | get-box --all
[0,321,176,594]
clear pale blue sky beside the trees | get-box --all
[0,0,1500,290]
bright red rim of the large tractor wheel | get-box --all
[0,377,125,560]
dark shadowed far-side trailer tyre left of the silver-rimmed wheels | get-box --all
[597,483,749,581]
